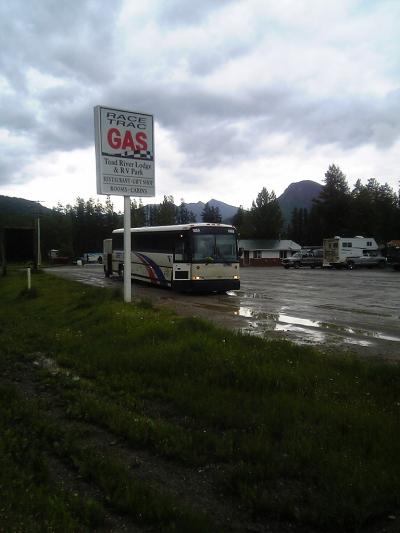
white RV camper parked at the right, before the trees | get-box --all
[323,235,385,268]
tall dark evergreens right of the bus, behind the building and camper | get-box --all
[233,165,400,246]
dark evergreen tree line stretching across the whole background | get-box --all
[0,165,400,257]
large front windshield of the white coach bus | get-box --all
[192,233,238,263]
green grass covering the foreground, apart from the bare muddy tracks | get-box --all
[0,272,400,531]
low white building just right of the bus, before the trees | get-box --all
[239,239,301,266]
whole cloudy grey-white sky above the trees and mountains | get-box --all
[0,0,400,211]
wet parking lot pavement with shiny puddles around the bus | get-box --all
[47,265,400,359]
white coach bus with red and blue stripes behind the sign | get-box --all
[103,223,240,292]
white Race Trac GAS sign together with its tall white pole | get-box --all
[94,106,155,302]
